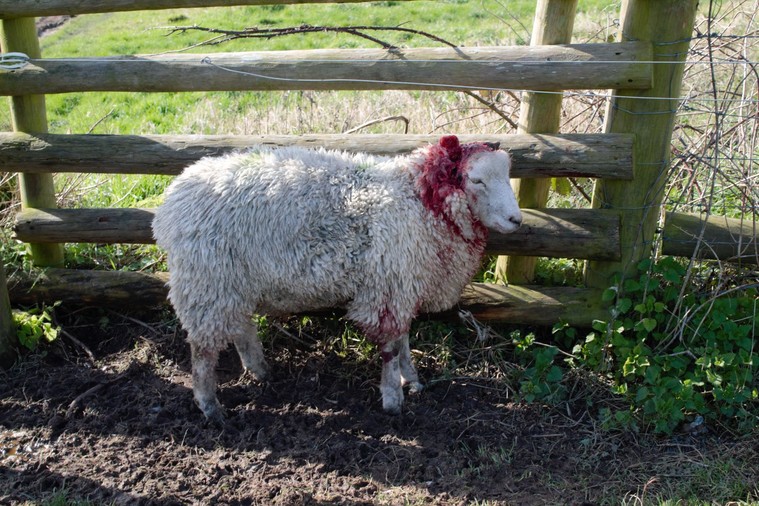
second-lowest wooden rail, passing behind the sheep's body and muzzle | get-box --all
[14,209,620,260]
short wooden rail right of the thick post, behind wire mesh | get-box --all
[662,212,759,264]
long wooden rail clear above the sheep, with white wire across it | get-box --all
[0,42,653,95]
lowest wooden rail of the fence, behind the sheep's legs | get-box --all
[9,269,606,325]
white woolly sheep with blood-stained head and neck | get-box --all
[153,135,522,423]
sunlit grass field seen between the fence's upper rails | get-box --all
[22,0,618,134]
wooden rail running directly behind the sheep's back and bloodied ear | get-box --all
[0,132,633,179]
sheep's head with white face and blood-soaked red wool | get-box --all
[419,135,522,237]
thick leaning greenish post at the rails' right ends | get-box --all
[585,0,698,288]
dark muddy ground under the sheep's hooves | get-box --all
[0,311,759,505]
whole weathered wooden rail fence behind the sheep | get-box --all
[0,0,756,364]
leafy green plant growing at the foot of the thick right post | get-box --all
[554,257,759,433]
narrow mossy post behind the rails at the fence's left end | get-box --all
[0,18,63,267]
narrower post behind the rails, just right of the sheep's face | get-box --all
[495,0,577,284]
